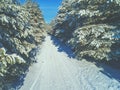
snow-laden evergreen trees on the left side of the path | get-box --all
[0,0,45,90]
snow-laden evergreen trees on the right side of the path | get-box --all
[54,0,120,61]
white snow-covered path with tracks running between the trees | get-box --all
[20,36,120,90]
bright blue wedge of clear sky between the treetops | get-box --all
[21,0,62,23]
